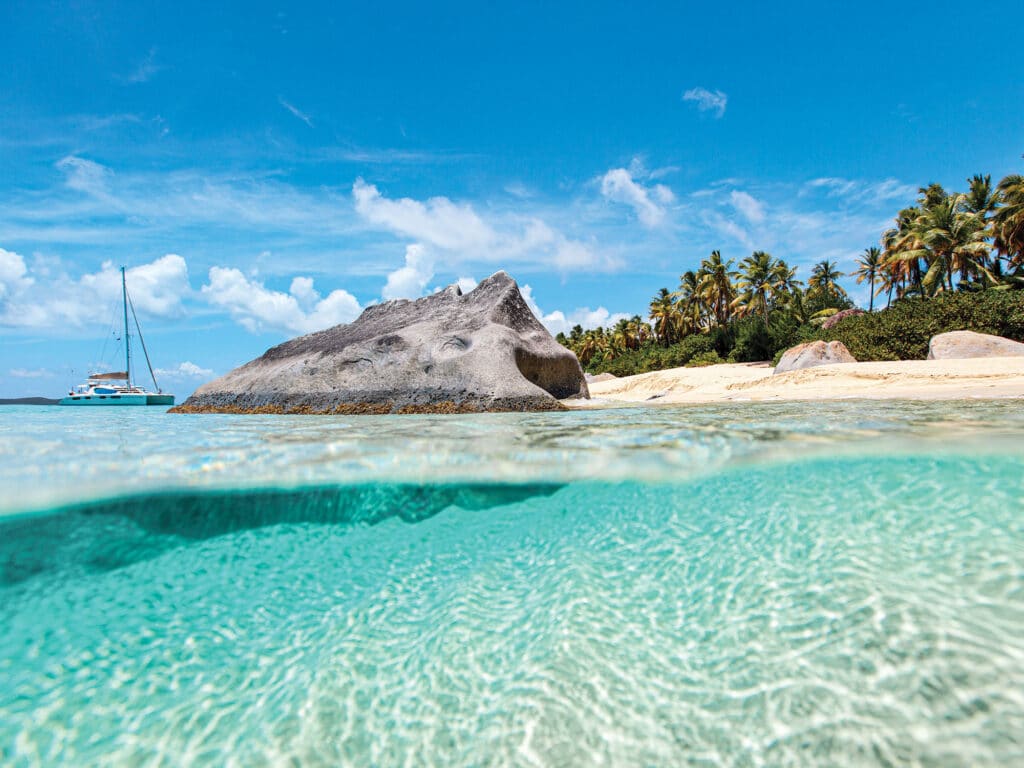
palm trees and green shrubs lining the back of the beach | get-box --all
[557,168,1024,376]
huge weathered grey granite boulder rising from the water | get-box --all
[172,272,590,414]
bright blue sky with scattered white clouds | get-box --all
[0,2,1024,396]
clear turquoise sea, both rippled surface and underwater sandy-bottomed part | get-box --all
[0,401,1024,766]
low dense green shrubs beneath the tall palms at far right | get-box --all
[799,291,1024,360]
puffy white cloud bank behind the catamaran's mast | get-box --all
[0,249,191,330]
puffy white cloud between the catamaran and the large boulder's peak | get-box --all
[201,266,362,334]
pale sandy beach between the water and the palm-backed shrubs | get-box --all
[564,357,1024,408]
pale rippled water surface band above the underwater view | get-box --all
[6,400,1024,515]
